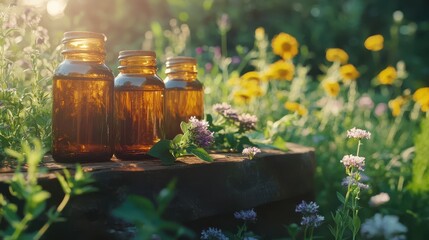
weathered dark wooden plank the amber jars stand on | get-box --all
[0,144,316,239]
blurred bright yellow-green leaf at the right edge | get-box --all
[408,118,429,194]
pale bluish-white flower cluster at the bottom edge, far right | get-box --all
[361,213,408,240]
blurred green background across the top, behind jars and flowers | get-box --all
[2,0,429,89]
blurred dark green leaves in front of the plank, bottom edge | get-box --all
[113,181,195,240]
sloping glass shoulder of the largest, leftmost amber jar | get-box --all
[54,60,114,80]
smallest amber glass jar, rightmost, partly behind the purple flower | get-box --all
[165,57,204,139]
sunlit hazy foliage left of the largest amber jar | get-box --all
[0,4,59,160]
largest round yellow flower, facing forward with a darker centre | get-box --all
[271,33,298,59]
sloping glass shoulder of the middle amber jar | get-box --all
[114,73,165,90]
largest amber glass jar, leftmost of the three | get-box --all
[52,32,114,162]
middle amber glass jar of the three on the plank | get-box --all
[114,50,165,160]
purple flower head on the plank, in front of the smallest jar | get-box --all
[189,117,214,148]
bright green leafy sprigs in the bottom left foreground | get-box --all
[0,140,95,240]
